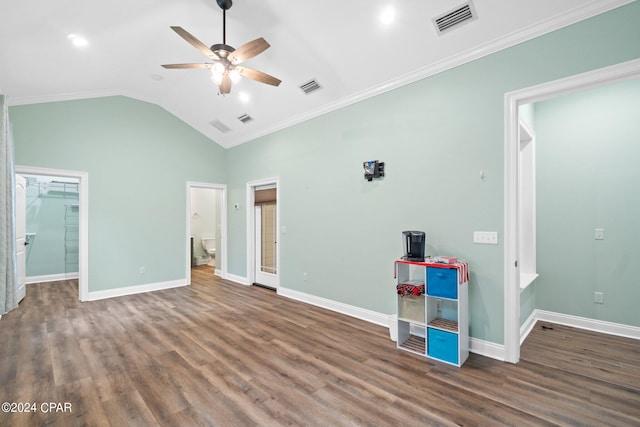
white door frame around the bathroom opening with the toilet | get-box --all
[184,181,227,286]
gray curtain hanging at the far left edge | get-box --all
[0,95,18,315]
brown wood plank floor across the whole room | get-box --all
[0,266,640,427]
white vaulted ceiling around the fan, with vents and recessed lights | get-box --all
[0,0,630,147]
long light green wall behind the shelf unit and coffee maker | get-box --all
[227,3,640,343]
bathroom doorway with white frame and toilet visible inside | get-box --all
[186,183,226,284]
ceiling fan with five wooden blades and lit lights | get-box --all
[163,0,281,95]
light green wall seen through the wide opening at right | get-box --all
[535,80,640,326]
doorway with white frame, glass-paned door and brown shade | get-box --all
[247,178,280,290]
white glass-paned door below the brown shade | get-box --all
[254,202,278,288]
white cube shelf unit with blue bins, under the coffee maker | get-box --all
[396,260,469,366]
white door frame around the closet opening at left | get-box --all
[15,165,89,301]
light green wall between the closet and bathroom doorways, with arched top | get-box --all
[9,97,226,291]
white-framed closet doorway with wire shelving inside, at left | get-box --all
[16,166,89,301]
